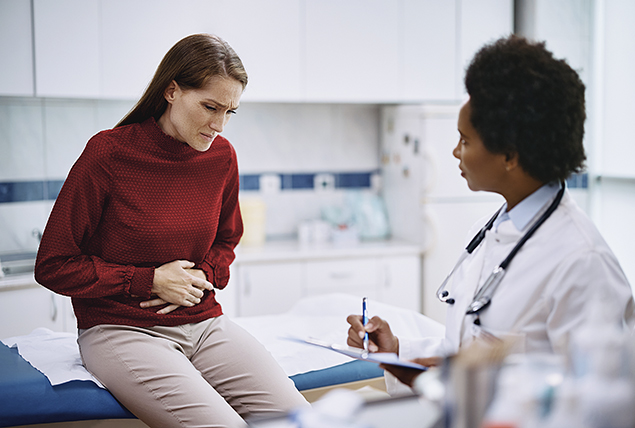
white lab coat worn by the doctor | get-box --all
[387,192,635,391]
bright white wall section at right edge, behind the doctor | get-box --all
[592,0,635,288]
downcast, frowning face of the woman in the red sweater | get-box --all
[158,76,243,152]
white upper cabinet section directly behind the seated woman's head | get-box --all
[26,0,302,101]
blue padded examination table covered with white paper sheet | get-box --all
[0,294,443,428]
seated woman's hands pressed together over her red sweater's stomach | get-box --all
[140,260,213,314]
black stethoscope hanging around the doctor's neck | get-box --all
[437,182,565,315]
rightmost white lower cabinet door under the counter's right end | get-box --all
[378,255,422,312]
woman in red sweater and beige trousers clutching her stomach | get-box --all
[35,34,308,427]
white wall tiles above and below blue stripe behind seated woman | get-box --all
[0,97,379,253]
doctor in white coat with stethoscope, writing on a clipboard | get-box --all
[347,36,634,389]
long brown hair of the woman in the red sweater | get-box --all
[116,34,248,127]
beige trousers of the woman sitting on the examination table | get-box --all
[78,316,309,428]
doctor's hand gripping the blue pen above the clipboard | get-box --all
[346,315,399,355]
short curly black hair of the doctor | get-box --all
[465,35,586,183]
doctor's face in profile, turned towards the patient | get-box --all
[452,101,507,193]
